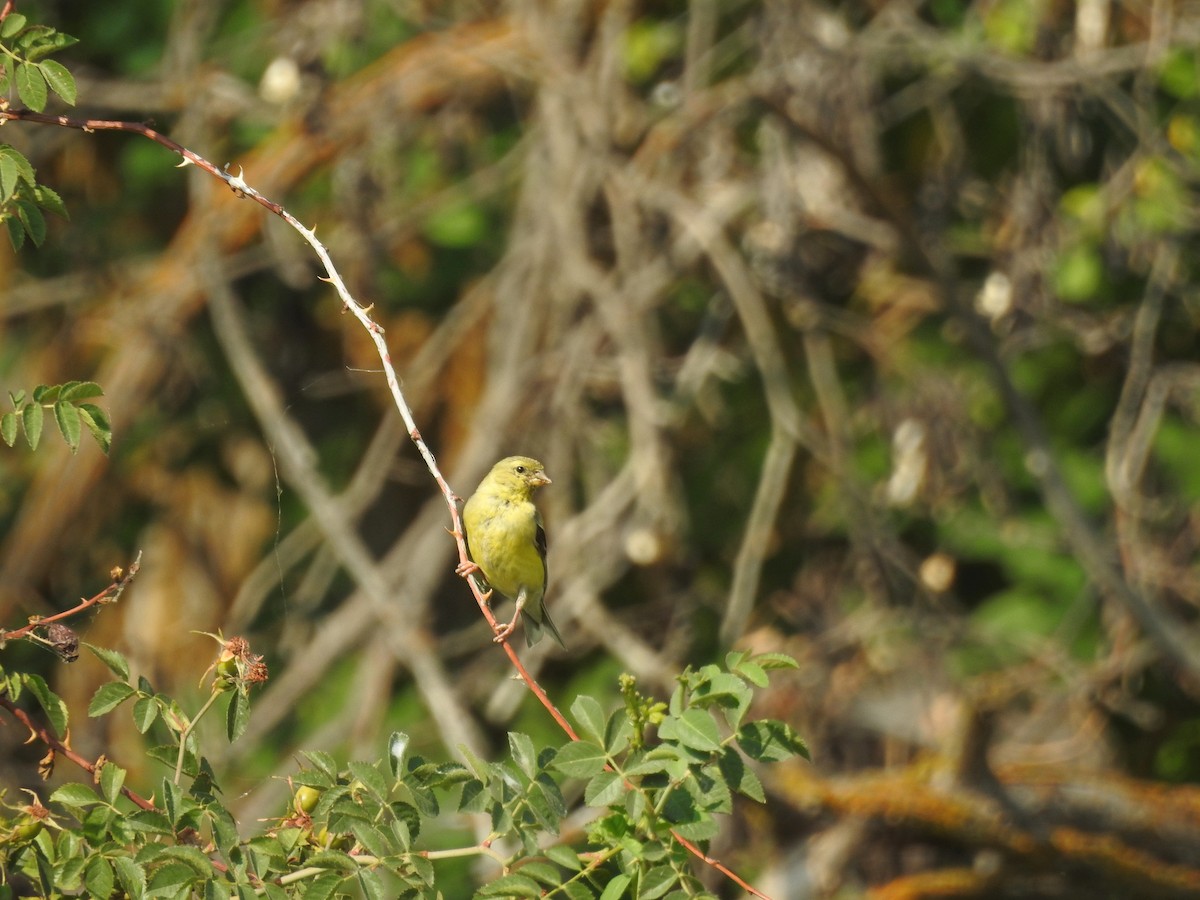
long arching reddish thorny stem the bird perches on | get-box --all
[0,107,770,900]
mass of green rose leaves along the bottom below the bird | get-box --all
[0,638,808,899]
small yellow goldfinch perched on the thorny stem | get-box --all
[458,456,566,649]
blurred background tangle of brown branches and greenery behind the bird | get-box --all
[0,0,1200,900]
